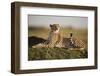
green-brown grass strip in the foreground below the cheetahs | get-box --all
[28,48,87,60]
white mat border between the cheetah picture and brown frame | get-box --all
[20,7,94,70]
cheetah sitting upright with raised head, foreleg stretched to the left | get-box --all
[32,24,62,47]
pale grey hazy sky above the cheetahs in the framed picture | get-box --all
[28,15,88,28]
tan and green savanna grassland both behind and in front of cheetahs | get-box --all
[28,27,88,60]
